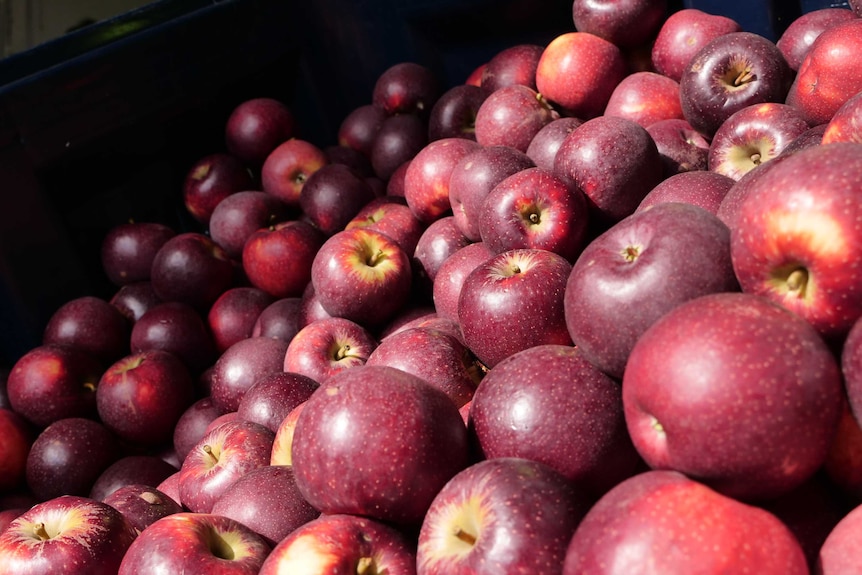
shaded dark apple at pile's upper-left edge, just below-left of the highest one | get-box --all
[182,152,255,226]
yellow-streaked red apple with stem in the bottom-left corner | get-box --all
[0,495,136,575]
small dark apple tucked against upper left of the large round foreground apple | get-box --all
[237,372,320,433]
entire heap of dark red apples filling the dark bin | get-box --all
[0,0,862,575]
